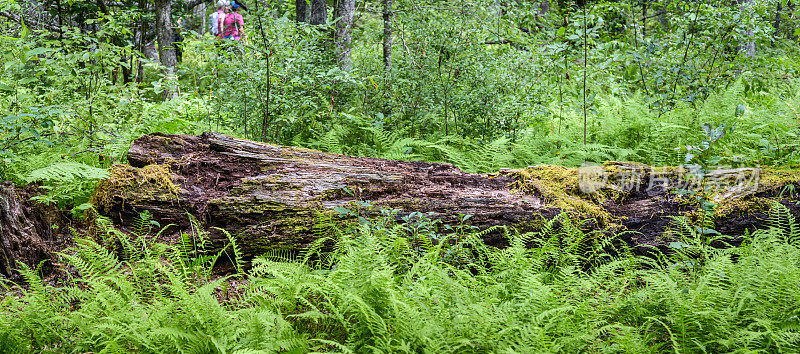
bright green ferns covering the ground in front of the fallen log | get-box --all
[0,204,800,353]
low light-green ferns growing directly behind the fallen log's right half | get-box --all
[298,79,800,173]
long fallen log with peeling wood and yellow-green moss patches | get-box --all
[94,133,798,256]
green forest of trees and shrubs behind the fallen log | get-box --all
[0,1,800,206]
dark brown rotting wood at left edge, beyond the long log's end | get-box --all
[0,182,72,281]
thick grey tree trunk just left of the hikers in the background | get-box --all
[155,0,178,100]
